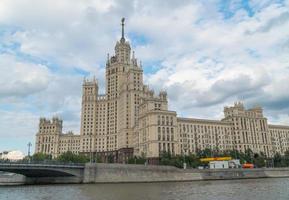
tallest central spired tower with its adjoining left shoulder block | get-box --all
[81,18,143,160]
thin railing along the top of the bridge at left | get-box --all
[0,160,85,167]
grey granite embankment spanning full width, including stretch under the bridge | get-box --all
[0,163,289,185]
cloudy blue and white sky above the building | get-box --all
[0,0,289,153]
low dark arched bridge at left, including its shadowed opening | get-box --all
[0,162,85,183]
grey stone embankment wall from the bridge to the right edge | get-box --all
[83,164,289,183]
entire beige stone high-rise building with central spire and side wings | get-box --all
[35,20,289,162]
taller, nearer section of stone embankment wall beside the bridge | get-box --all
[83,164,202,183]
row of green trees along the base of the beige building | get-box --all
[20,149,289,168]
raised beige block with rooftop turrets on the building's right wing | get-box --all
[223,102,273,156]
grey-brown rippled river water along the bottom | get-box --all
[0,178,289,200]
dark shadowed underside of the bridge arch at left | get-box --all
[0,168,75,177]
